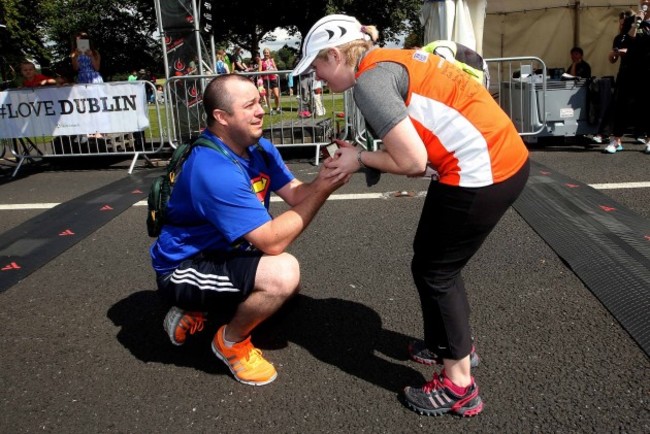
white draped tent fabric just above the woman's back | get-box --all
[420,0,487,52]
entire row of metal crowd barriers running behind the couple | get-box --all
[0,57,546,176]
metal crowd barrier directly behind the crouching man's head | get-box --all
[165,70,352,165]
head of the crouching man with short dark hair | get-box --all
[222,81,264,146]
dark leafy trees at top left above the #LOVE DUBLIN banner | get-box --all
[0,0,162,79]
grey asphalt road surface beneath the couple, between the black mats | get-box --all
[0,144,650,434]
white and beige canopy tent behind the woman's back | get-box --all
[420,0,639,76]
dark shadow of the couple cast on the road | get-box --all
[107,291,424,393]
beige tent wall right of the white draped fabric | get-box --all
[481,0,639,77]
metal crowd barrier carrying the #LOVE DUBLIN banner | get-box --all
[0,81,166,177]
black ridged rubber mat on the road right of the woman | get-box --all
[514,163,650,356]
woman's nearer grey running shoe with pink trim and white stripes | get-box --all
[404,370,483,417]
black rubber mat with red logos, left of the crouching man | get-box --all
[0,170,161,293]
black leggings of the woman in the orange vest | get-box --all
[411,162,530,360]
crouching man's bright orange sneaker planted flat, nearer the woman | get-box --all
[212,325,278,386]
